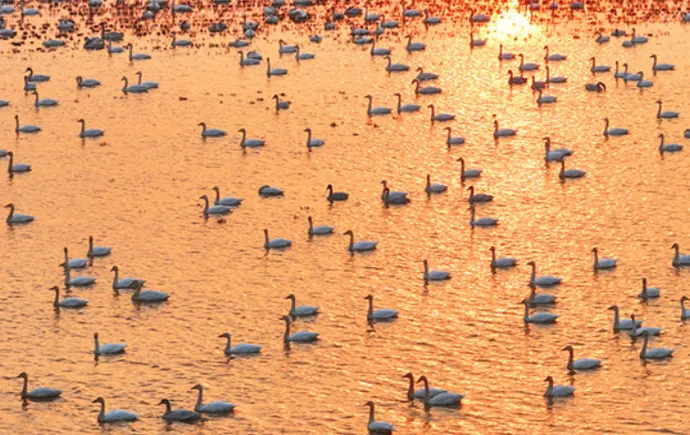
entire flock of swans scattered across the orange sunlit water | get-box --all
[0,0,690,433]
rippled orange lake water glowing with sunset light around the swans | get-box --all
[0,1,690,434]
